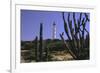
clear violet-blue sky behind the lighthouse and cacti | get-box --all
[21,10,90,41]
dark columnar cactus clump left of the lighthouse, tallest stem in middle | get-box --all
[35,23,48,62]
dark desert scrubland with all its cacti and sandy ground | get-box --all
[21,12,90,63]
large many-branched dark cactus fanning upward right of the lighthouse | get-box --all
[60,12,89,59]
